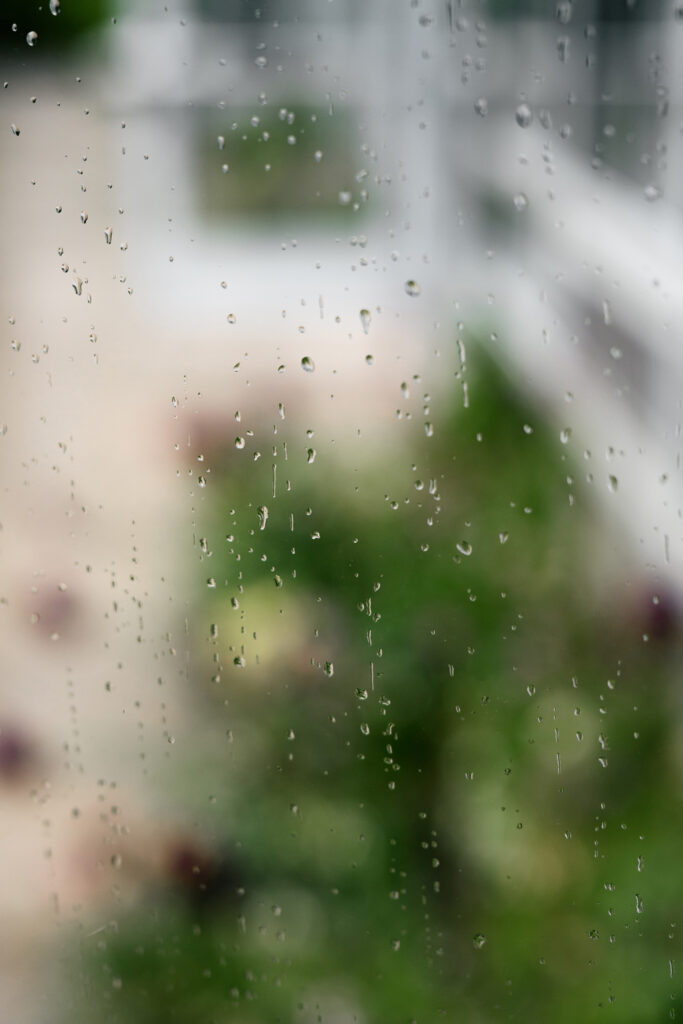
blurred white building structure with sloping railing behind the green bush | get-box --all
[106,0,683,597]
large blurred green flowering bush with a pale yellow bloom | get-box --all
[77,339,683,1024]
